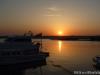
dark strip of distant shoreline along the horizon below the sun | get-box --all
[0,36,100,41]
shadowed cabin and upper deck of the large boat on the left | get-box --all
[0,36,40,56]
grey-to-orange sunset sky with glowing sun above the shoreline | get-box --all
[0,0,100,35]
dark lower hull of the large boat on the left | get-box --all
[0,52,48,65]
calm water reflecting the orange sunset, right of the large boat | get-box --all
[0,40,100,75]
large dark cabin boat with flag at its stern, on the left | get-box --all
[0,36,49,65]
